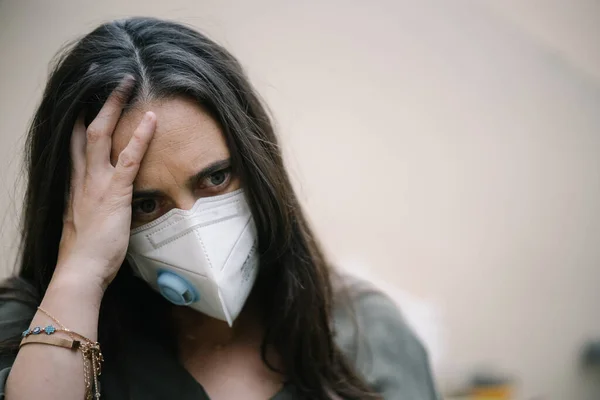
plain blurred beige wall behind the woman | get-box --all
[0,0,600,400]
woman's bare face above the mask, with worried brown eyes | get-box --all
[111,97,240,228]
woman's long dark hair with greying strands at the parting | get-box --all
[4,18,375,399]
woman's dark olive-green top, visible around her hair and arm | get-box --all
[0,282,439,400]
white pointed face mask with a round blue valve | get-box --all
[127,189,258,326]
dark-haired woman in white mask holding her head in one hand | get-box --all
[0,18,435,400]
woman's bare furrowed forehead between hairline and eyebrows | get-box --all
[111,97,229,190]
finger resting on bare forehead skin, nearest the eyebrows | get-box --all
[114,112,156,187]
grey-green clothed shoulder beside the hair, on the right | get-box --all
[334,276,437,400]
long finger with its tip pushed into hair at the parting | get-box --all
[86,76,134,173]
